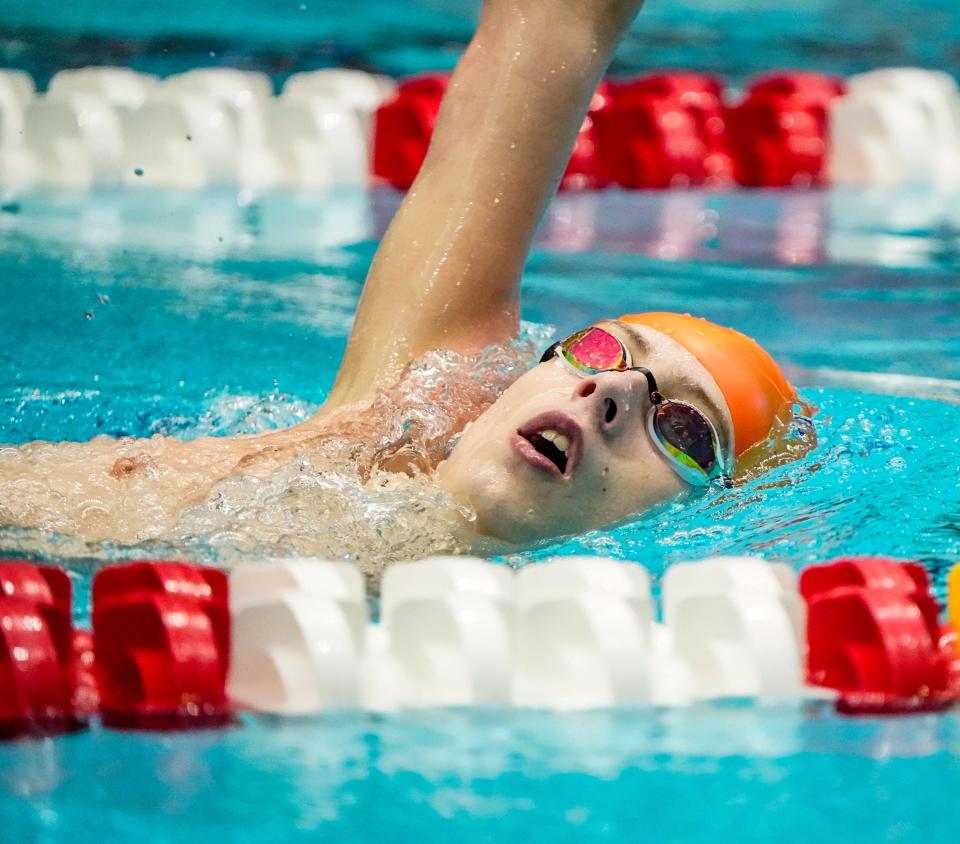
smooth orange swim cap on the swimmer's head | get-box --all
[620,312,797,457]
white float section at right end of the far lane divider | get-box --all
[829,68,960,186]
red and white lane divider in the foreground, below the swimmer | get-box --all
[0,557,960,738]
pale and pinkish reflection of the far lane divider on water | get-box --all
[7,187,960,268]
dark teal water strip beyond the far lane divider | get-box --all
[0,0,960,84]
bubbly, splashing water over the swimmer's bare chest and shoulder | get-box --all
[0,338,542,575]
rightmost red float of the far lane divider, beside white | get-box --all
[728,71,844,187]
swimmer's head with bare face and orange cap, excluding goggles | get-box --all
[440,313,796,543]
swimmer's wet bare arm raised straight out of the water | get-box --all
[327,0,642,409]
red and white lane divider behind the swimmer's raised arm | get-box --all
[0,67,960,190]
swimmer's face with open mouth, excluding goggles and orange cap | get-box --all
[439,320,732,544]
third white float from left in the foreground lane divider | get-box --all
[512,557,654,710]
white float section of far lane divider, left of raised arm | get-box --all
[0,67,396,190]
